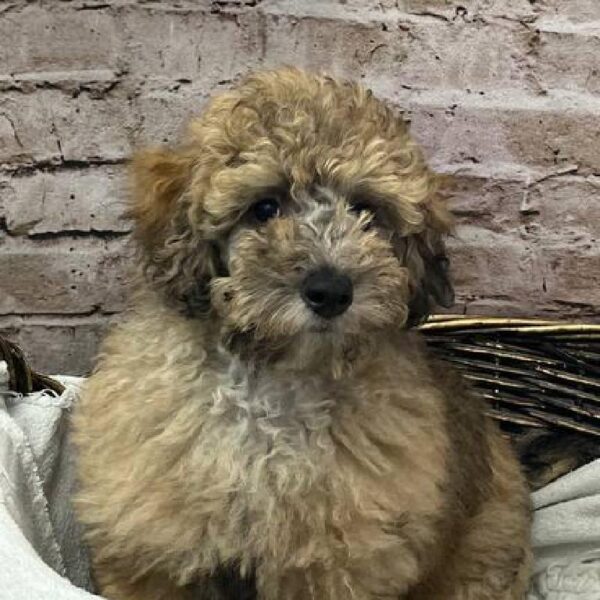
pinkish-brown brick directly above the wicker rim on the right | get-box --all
[449,224,600,319]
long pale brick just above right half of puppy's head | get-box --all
[265,11,534,98]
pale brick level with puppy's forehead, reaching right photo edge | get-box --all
[406,90,600,174]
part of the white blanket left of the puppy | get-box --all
[0,362,99,600]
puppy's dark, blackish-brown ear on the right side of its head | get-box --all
[404,197,454,327]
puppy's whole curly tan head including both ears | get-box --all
[132,69,453,356]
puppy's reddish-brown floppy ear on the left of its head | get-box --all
[128,148,218,316]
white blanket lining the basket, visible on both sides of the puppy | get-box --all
[0,362,600,600]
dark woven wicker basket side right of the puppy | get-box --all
[421,317,600,442]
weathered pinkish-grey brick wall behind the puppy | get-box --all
[0,0,600,373]
